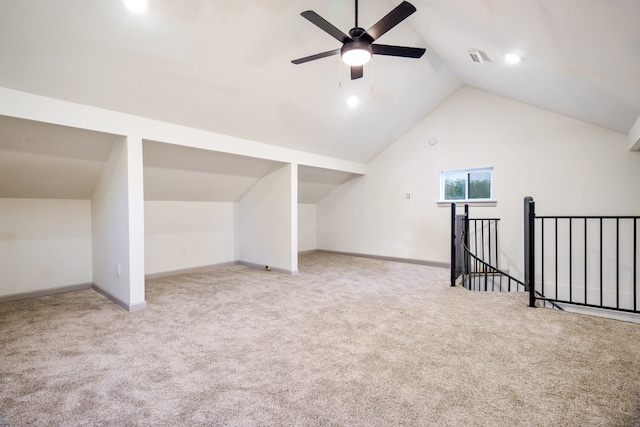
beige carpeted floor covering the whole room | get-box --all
[0,253,640,426]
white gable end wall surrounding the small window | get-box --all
[317,88,640,274]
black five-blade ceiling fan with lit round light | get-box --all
[291,0,426,80]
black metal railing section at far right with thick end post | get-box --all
[525,198,640,314]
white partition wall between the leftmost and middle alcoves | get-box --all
[92,137,146,310]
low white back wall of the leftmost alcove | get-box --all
[0,199,92,296]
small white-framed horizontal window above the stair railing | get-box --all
[440,168,493,202]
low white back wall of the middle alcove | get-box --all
[144,201,238,274]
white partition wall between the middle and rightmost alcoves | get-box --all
[238,165,298,273]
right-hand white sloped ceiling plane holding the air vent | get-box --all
[415,0,640,134]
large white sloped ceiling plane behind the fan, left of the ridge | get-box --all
[0,0,461,162]
